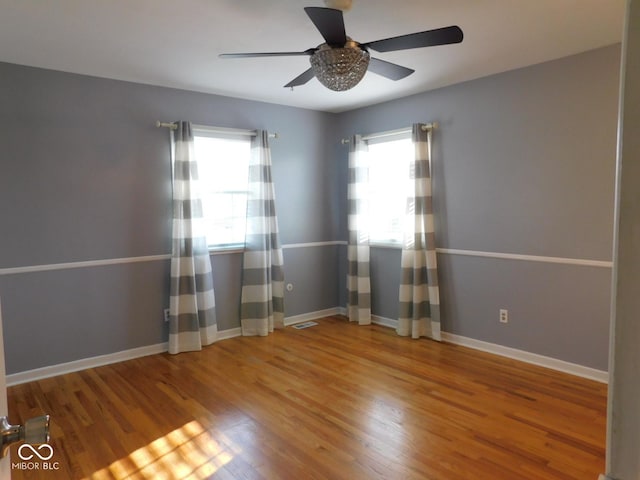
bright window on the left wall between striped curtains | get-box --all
[193,128,251,248]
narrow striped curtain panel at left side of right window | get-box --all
[347,135,371,325]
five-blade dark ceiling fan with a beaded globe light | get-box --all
[220,7,463,91]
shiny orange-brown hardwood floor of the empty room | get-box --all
[9,317,607,480]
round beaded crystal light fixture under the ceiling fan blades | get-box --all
[309,42,370,92]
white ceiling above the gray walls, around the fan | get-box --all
[0,0,625,112]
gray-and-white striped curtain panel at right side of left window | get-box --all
[240,130,284,336]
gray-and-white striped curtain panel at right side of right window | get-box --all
[397,124,440,340]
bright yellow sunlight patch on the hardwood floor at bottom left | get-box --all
[87,420,234,480]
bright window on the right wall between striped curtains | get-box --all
[366,134,414,245]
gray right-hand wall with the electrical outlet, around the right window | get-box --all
[334,46,620,370]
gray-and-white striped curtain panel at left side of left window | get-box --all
[169,122,218,353]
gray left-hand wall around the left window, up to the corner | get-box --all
[0,63,339,373]
